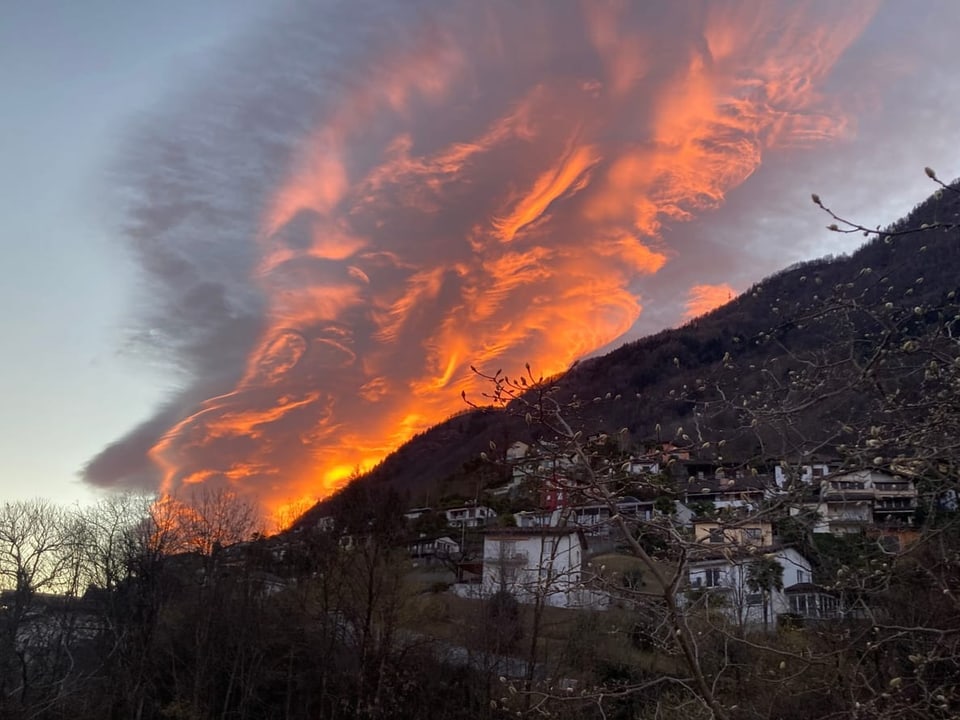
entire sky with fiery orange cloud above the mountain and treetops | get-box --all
[0,0,960,513]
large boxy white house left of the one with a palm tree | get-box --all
[481,528,605,607]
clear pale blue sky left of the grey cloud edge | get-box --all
[0,0,280,501]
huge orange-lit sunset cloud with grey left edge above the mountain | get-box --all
[87,2,874,510]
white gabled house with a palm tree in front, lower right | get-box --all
[689,548,813,625]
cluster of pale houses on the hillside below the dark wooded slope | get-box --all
[394,443,920,623]
